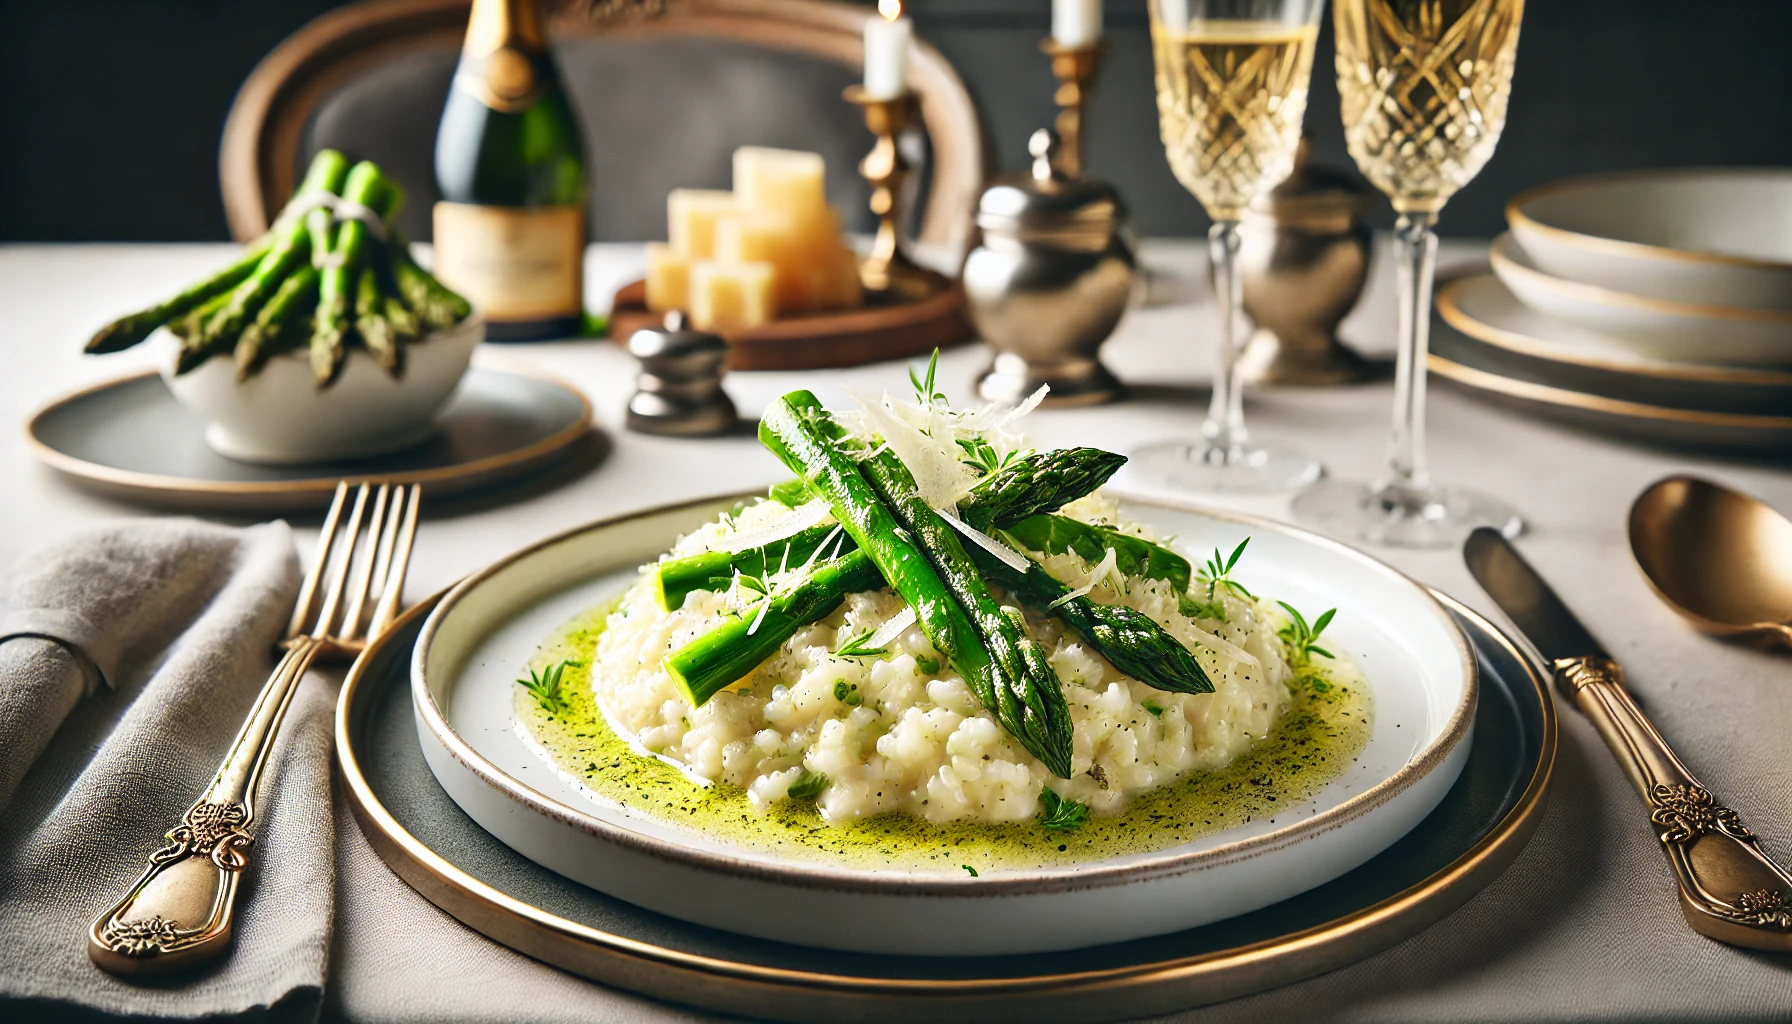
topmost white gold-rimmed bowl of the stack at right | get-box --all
[1505,170,1792,310]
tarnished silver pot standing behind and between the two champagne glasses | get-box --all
[1238,138,1373,386]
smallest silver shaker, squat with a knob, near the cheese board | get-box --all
[629,312,737,438]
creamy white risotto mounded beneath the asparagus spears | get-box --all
[591,495,1292,823]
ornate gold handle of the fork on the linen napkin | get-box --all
[88,637,324,976]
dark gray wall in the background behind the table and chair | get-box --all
[0,0,1792,240]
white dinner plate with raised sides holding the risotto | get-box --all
[412,495,1478,956]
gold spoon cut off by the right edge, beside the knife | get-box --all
[1631,477,1792,647]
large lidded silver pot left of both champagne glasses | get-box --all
[964,129,1136,405]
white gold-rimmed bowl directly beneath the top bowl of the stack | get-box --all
[1493,233,1792,366]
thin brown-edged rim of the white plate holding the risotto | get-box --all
[410,491,1480,897]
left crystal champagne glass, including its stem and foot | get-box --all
[1134,0,1322,493]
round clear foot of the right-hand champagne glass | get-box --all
[1294,481,1525,547]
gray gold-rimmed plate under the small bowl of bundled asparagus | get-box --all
[25,364,607,515]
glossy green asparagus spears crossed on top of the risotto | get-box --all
[656,373,1213,777]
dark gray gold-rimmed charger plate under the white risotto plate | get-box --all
[337,595,1555,1022]
